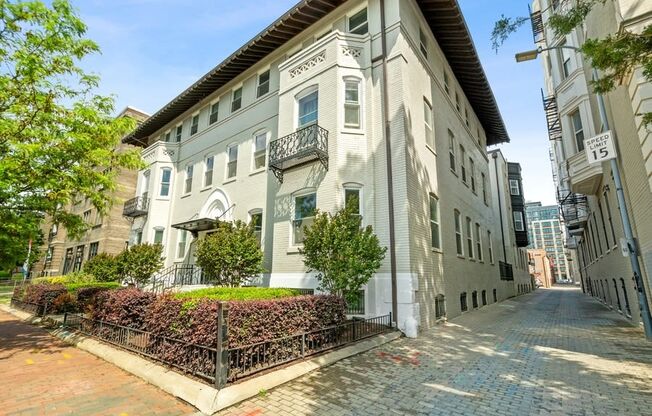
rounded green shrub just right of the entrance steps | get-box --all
[197,221,264,287]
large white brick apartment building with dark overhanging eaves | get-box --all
[125,0,515,327]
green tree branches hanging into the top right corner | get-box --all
[491,0,652,124]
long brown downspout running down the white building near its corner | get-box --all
[374,0,398,323]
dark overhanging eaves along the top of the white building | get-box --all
[123,0,509,146]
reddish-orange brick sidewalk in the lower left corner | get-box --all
[0,311,197,416]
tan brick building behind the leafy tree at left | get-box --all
[31,107,149,276]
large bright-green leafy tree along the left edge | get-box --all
[0,0,141,263]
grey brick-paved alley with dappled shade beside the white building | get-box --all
[221,287,652,416]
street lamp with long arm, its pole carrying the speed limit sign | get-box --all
[515,45,652,341]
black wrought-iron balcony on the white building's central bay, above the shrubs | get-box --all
[269,124,328,183]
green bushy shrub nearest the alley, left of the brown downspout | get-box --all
[300,208,387,302]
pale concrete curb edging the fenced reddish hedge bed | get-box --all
[0,305,401,415]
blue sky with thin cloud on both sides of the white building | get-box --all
[72,0,556,204]
